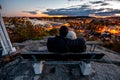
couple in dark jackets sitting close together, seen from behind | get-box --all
[47,26,86,52]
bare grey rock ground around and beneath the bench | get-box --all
[0,40,120,80]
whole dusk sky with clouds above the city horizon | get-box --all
[0,0,120,17]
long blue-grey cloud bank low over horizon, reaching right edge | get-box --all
[43,5,120,16]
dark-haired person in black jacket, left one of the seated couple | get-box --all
[47,26,68,52]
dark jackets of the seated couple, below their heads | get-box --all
[47,36,86,52]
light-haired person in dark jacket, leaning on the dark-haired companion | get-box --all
[66,26,86,52]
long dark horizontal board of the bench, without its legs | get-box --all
[21,51,104,61]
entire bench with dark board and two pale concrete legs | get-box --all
[21,50,104,75]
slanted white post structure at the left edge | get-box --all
[0,6,16,55]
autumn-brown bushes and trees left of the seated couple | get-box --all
[4,18,58,42]
